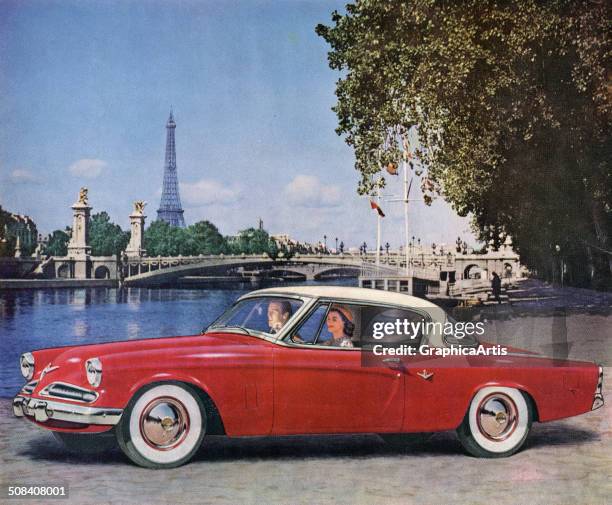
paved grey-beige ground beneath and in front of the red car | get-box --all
[0,374,612,505]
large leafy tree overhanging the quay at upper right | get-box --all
[316,0,612,287]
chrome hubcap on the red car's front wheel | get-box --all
[140,398,189,451]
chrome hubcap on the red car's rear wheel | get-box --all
[476,393,518,441]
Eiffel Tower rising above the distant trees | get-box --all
[157,109,185,228]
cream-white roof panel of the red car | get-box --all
[245,286,442,310]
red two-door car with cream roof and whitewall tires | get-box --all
[13,286,603,468]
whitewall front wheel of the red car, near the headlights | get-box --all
[117,382,206,468]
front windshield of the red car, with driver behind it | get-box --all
[206,296,302,335]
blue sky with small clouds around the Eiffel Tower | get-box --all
[0,0,471,246]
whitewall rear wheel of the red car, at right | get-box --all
[457,387,533,458]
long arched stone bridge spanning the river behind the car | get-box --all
[42,250,520,295]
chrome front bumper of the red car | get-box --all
[13,395,123,426]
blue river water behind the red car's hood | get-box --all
[0,279,356,398]
